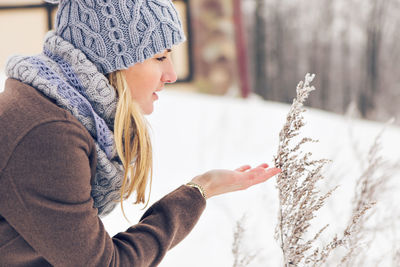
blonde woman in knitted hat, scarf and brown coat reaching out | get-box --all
[0,0,279,266]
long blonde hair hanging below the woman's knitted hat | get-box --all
[108,70,153,217]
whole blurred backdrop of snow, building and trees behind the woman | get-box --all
[0,0,400,267]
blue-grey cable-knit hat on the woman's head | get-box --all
[45,0,186,74]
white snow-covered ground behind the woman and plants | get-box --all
[0,76,400,267]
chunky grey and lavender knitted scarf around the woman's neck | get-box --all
[6,31,123,216]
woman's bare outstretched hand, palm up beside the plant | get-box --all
[192,163,281,198]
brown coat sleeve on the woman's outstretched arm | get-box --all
[0,121,206,267]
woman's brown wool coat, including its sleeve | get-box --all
[0,79,206,267]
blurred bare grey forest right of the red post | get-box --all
[247,0,400,123]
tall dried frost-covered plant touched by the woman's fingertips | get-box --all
[274,74,370,266]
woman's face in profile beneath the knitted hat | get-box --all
[123,49,177,115]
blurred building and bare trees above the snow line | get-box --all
[0,0,400,121]
